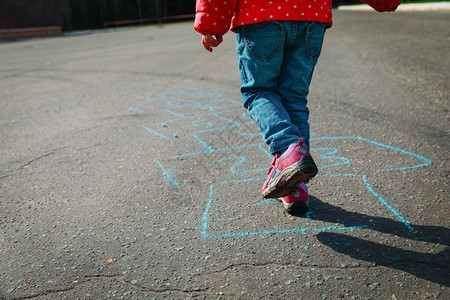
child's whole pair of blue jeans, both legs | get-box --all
[235,21,329,154]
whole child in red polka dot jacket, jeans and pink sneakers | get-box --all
[195,0,400,214]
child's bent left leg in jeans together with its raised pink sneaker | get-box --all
[236,22,317,198]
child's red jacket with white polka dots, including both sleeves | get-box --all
[194,0,401,35]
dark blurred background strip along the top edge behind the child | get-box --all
[0,0,426,31]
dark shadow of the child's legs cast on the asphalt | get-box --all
[309,196,450,287]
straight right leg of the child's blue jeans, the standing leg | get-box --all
[279,22,328,149]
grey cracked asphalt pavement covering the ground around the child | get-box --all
[0,11,450,300]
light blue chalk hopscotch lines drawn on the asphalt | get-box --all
[129,87,431,238]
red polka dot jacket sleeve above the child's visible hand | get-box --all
[194,0,237,35]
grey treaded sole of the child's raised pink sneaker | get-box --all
[262,156,318,198]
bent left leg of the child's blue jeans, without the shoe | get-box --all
[236,22,300,153]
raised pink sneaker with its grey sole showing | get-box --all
[262,139,318,198]
